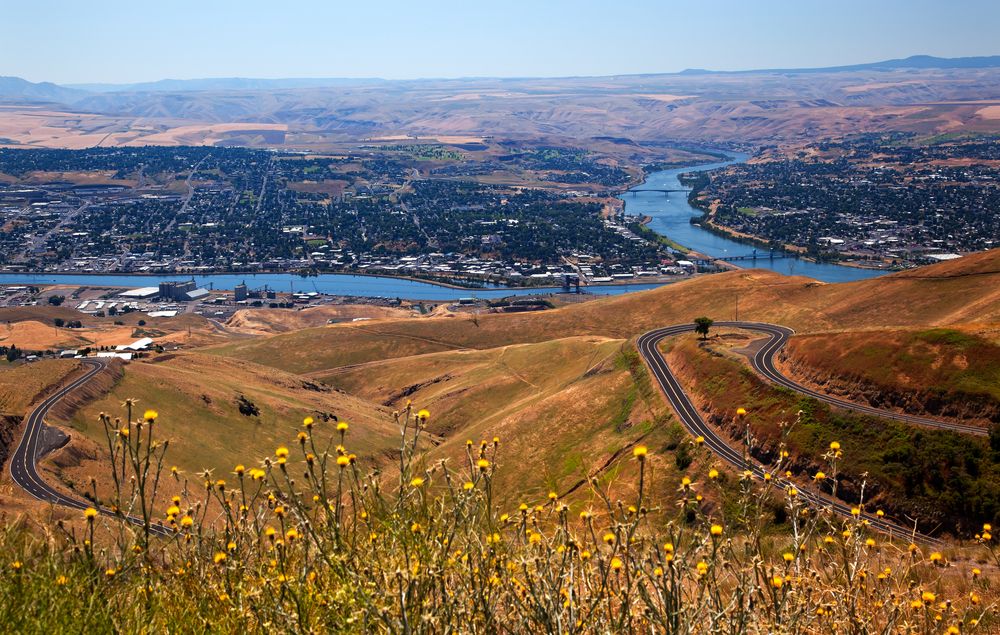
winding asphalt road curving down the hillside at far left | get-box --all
[9,359,172,535]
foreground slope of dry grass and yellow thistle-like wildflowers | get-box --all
[0,400,1000,634]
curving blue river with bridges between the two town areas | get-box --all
[619,153,888,282]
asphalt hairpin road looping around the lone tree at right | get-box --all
[636,322,942,545]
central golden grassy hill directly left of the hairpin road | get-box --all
[318,337,694,506]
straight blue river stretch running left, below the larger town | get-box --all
[0,273,672,301]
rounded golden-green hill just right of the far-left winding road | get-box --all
[53,354,398,492]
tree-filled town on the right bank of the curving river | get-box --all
[703,133,1000,266]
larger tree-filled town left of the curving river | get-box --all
[0,145,694,286]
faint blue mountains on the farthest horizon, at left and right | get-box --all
[0,55,1000,104]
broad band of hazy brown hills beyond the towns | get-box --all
[0,67,1000,149]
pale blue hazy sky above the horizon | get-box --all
[7,0,1000,83]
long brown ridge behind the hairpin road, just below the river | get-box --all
[206,249,1000,373]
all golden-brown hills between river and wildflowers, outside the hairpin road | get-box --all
[3,250,1000,528]
